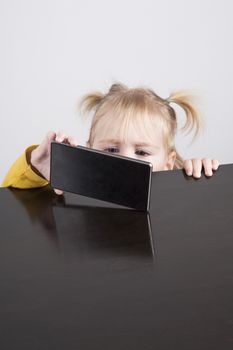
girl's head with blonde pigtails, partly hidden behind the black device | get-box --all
[80,83,201,171]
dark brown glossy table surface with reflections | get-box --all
[0,164,233,350]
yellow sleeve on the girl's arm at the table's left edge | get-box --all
[2,145,49,189]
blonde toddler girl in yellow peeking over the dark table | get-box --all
[2,83,219,194]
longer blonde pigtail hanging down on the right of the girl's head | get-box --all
[166,91,203,142]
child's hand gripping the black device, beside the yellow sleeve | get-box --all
[29,131,78,194]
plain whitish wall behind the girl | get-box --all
[0,0,233,181]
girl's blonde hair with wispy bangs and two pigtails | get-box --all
[79,82,202,169]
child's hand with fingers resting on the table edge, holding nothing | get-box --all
[183,158,219,178]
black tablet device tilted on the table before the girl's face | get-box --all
[50,141,153,211]
